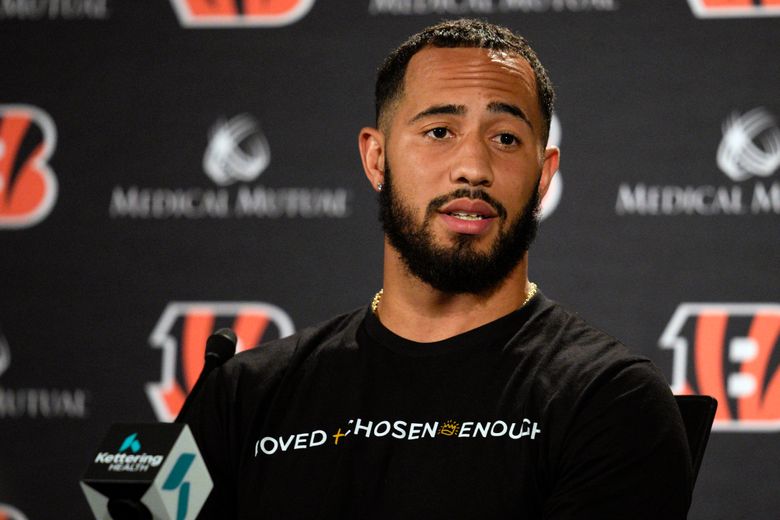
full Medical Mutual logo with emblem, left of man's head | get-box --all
[109,113,352,220]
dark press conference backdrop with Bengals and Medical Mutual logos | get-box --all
[0,0,780,519]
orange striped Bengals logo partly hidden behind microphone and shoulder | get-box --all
[146,302,295,421]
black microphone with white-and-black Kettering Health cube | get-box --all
[81,329,237,520]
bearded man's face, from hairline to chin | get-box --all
[380,47,557,293]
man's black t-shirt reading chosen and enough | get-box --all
[187,294,692,519]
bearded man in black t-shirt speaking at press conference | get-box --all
[189,20,691,519]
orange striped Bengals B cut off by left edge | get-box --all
[0,105,57,228]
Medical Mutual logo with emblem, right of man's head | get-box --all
[615,107,780,216]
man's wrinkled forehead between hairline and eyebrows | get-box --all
[401,47,541,124]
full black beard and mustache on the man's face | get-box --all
[379,163,539,294]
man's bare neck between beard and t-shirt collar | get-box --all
[377,245,530,342]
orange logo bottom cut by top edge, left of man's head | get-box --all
[171,0,314,27]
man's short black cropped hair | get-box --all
[374,18,555,142]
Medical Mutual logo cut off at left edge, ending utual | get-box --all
[0,332,88,418]
